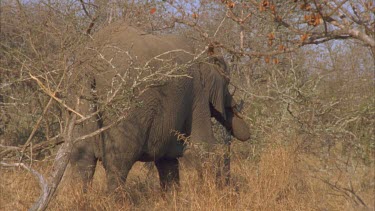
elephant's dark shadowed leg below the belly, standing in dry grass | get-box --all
[155,158,180,190]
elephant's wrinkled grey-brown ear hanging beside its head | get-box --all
[201,57,230,119]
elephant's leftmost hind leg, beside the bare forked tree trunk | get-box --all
[70,143,98,192]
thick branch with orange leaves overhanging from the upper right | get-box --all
[170,0,375,57]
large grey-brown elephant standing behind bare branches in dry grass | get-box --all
[70,23,250,191]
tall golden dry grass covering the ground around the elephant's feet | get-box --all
[0,138,375,210]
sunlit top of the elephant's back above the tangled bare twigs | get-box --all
[89,22,194,66]
